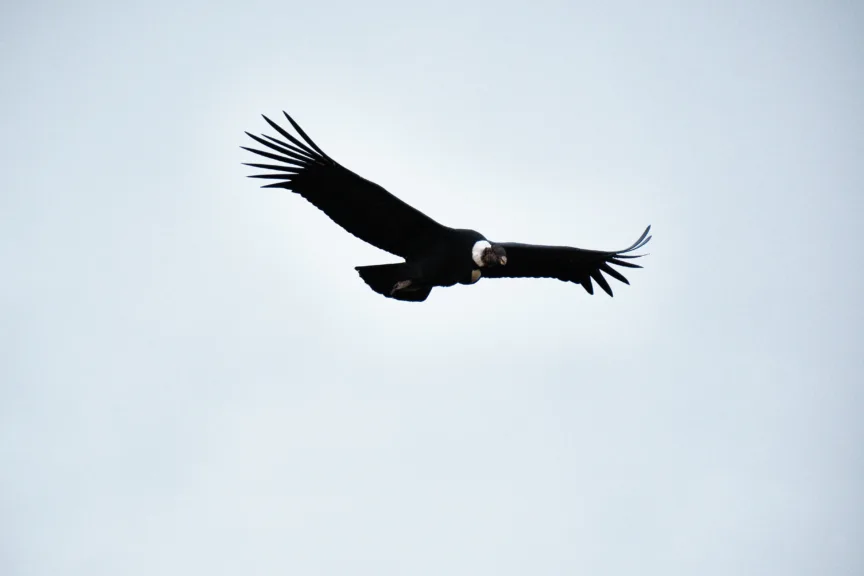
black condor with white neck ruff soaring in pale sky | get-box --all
[241,111,651,302]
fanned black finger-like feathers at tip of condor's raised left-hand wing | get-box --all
[241,110,337,190]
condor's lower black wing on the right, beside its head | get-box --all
[483,226,651,296]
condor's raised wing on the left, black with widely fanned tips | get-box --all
[241,111,445,258]
